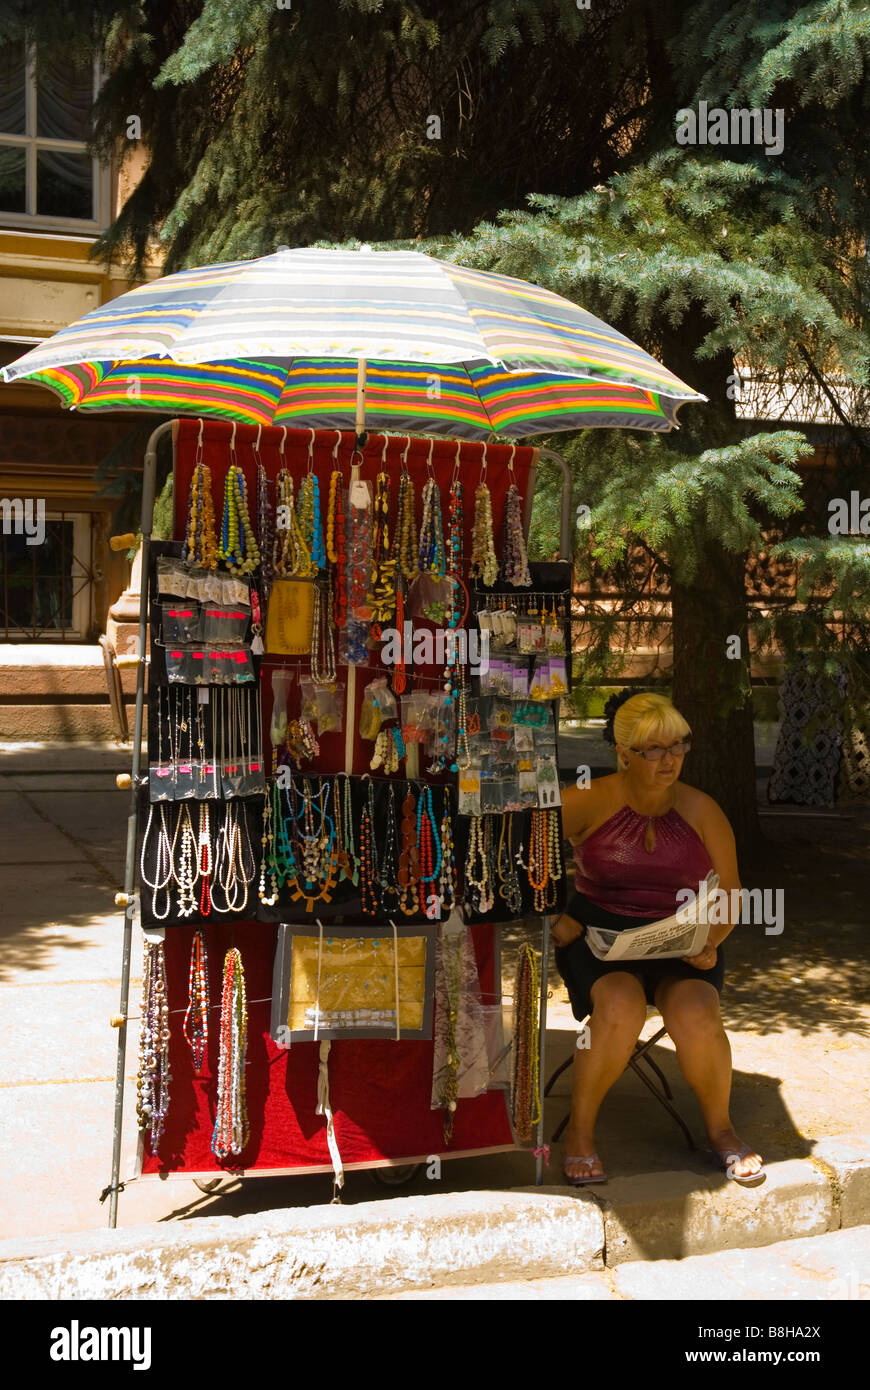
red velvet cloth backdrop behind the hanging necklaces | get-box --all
[142,420,535,1173]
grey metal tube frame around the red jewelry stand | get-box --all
[100,420,571,1229]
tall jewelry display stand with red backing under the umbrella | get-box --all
[107,420,570,1226]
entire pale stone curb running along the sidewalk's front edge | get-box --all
[0,1136,870,1300]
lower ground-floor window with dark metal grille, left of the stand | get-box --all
[0,512,93,642]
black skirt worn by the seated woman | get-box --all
[556,892,725,1022]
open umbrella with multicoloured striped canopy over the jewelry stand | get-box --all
[3,247,706,439]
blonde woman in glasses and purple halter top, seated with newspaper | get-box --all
[553,691,764,1187]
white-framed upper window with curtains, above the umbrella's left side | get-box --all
[0,43,110,234]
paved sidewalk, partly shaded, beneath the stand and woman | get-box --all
[0,746,870,1237]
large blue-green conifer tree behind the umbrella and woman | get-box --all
[6,0,870,851]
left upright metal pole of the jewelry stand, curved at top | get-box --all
[103,420,172,1229]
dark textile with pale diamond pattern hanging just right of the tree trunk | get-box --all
[767,656,845,806]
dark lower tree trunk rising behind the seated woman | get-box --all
[671,541,762,856]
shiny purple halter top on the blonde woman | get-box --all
[574,806,713,919]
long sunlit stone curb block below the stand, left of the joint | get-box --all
[0,1188,605,1300]
